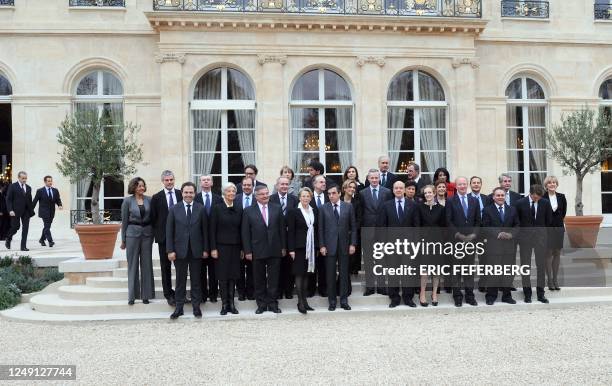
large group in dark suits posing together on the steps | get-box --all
[122,156,567,319]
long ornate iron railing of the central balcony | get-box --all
[153,0,482,18]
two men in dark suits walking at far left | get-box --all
[0,171,62,251]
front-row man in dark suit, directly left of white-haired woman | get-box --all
[166,182,209,319]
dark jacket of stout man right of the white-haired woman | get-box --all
[242,203,287,259]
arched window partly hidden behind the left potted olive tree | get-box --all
[74,70,125,216]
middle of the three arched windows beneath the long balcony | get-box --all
[290,68,353,184]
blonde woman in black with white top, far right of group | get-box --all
[544,176,567,291]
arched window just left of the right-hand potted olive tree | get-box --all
[506,76,548,194]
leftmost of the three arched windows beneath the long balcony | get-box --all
[190,67,255,190]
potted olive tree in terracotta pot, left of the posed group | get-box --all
[56,111,142,259]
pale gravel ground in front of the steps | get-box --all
[0,306,612,385]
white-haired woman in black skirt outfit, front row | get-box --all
[209,182,242,315]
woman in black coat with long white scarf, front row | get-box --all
[287,188,318,314]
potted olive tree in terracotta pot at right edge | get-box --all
[547,107,612,248]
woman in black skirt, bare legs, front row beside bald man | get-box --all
[417,185,446,307]
